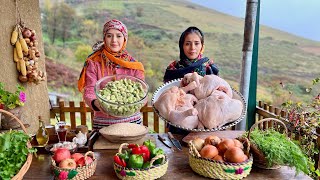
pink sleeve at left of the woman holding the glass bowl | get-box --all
[83,61,98,110]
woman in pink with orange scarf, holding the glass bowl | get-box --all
[78,19,144,129]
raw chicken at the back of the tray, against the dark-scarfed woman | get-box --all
[181,72,232,100]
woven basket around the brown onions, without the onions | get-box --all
[189,139,252,179]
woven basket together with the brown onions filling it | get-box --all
[189,136,252,179]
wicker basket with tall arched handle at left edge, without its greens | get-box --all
[0,109,32,180]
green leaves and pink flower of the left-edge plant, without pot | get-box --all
[0,82,26,109]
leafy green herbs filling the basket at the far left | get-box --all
[0,130,36,179]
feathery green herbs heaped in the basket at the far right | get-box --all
[250,129,312,174]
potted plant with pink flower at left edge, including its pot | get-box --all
[0,82,26,129]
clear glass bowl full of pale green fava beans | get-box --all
[94,74,149,117]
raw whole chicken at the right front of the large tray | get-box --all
[195,90,243,129]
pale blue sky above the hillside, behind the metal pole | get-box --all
[190,0,320,41]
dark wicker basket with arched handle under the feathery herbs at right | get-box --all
[248,118,288,169]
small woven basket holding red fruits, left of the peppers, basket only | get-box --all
[51,151,97,180]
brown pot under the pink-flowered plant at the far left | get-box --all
[1,106,22,130]
